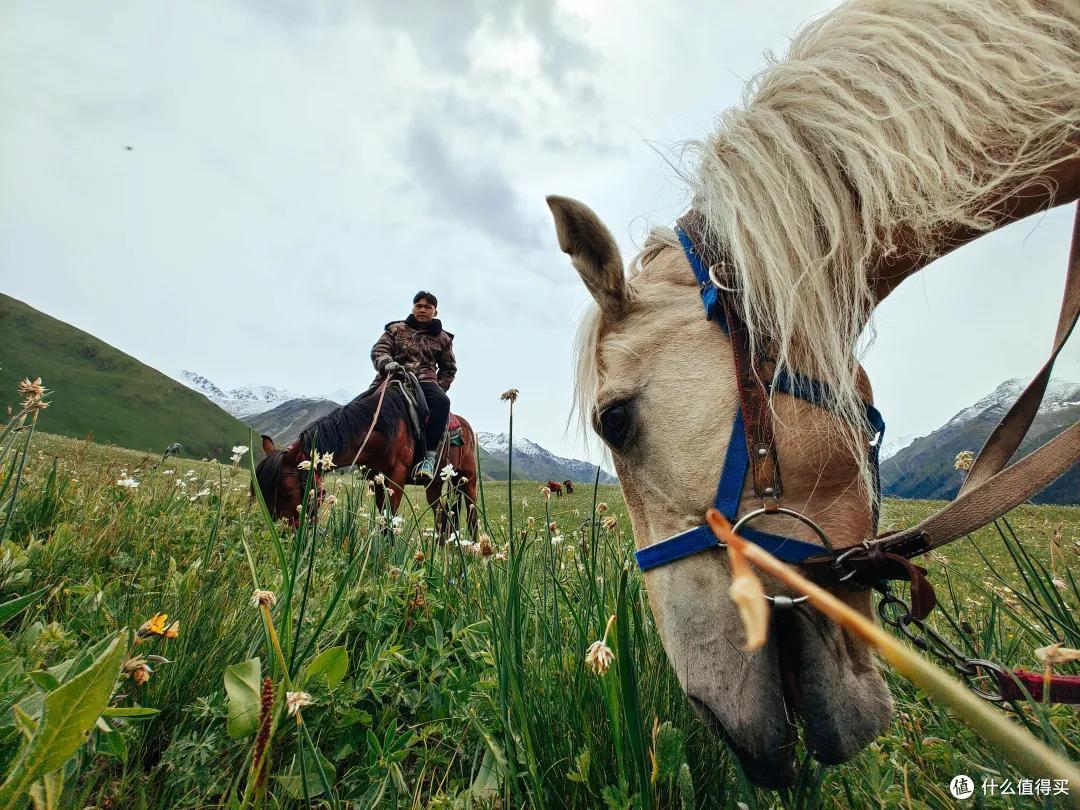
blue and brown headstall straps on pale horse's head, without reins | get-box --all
[634,212,885,602]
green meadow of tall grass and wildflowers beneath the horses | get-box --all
[0,421,1080,808]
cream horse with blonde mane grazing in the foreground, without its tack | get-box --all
[549,0,1080,786]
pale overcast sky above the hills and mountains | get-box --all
[0,0,1080,468]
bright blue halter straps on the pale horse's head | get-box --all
[634,229,885,571]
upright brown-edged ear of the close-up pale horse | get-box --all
[548,194,626,321]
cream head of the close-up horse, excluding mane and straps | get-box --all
[549,198,891,786]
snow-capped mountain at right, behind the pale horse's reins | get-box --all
[881,379,1080,504]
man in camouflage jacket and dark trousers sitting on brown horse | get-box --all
[372,289,458,483]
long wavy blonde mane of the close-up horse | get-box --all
[578,0,1080,501]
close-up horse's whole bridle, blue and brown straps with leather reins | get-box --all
[634,204,1080,701]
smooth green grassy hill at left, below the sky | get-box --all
[0,295,248,459]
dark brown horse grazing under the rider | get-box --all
[255,381,478,539]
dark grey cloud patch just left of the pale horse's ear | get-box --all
[405,119,540,249]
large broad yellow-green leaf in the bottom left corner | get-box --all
[0,634,126,810]
